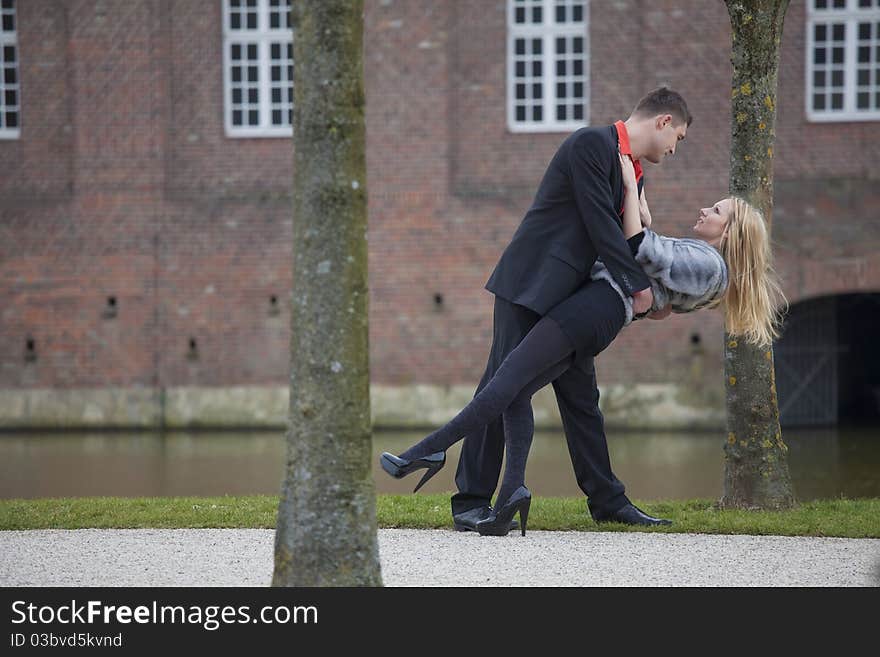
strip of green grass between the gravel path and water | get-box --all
[0,493,880,538]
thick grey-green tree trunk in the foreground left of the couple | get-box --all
[272,0,382,586]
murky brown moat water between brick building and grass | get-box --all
[0,422,880,500]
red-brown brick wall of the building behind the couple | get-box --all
[0,0,880,424]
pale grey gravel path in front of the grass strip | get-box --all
[0,529,880,587]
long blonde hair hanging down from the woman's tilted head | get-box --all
[718,196,787,346]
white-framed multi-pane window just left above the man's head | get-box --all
[507,0,590,132]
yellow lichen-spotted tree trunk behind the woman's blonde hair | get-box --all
[720,0,795,509]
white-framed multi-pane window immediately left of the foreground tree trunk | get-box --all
[223,0,293,137]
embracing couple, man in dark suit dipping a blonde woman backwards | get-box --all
[380,87,782,536]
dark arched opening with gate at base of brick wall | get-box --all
[773,293,880,426]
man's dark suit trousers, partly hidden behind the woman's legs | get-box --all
[452,296,629,517]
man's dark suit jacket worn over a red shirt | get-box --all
[486,125,650,315]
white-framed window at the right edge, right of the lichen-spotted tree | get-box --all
[806,0,880,121]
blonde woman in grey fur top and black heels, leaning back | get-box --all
[380,155,784,536]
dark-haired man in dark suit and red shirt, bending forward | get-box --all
[452,87,691,531]
